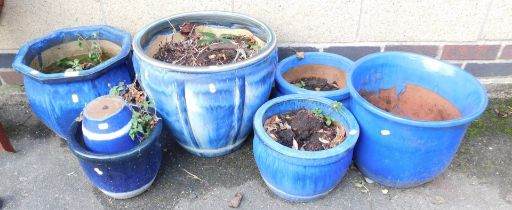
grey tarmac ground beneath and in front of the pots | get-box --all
[0,86,512,210]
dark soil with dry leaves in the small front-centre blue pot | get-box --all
[264,109,346,151]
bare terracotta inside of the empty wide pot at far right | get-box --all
[359,84,462,121]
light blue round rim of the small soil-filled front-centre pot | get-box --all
[253,94,360,159]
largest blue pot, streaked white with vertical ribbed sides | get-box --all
[133,11,277,157]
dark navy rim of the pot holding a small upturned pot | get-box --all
[68,119,163,162]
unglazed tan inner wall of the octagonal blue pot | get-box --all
[30,40,121,71]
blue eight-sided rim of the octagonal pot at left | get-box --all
[12,25,131,82]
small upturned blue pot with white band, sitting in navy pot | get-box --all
[82,95,139,154]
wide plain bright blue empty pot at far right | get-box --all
[348,52,488,188]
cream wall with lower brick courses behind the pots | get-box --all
[0,0,512,84]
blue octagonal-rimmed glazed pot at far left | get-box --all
[13,26,134,139]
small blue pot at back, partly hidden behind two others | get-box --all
[275,52,354,108]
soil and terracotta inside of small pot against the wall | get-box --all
[283,64,346,91]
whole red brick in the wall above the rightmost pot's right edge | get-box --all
[441,45,500,60]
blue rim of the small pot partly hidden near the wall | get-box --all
[276,52,354,97]
